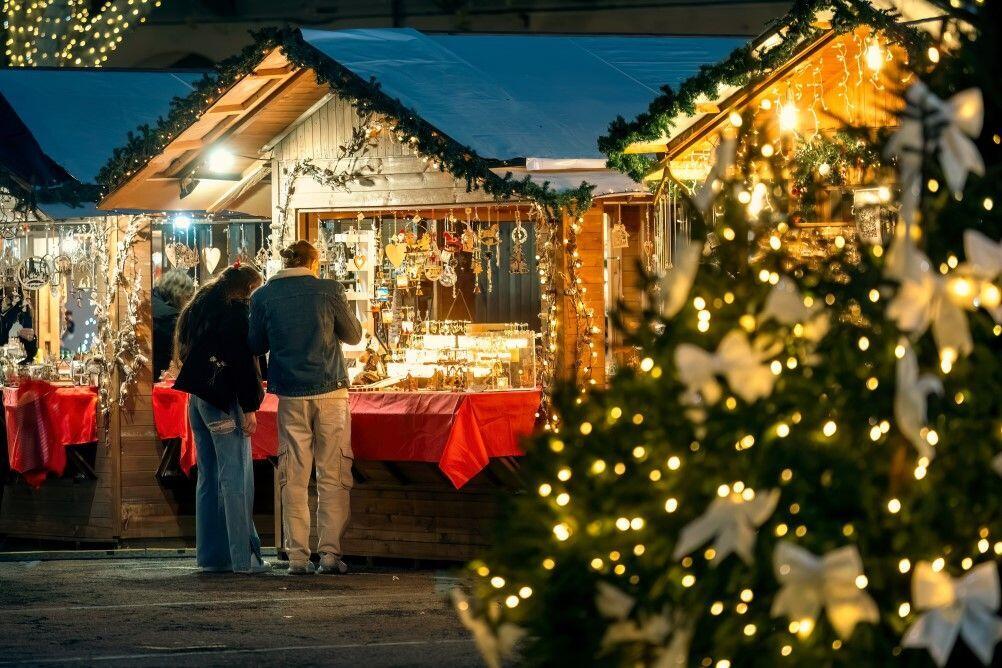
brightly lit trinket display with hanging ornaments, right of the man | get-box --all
[300,204,540,391]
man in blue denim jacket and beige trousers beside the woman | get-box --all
[249,241,362,575]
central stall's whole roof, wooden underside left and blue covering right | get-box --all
[101,29,743,215]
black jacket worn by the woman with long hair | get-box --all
[174,301,265,413]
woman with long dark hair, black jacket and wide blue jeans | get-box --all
[174,264,271,573]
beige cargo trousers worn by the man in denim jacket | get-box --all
[279,390,353,565]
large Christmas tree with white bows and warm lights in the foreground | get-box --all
[455,3,1002,668]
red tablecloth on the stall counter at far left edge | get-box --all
[3,381,97,487]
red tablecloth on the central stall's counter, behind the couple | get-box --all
[153,383,539,489]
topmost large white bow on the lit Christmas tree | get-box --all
[885,81,985,227]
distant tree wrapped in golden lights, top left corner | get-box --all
[3,0,160,67]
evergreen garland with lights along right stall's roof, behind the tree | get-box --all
[598,0,930,181]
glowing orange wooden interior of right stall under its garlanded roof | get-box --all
[625,28,910,267]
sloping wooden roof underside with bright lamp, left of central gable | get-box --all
[100,49,328,216]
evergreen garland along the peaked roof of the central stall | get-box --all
[97,28,594,214]
